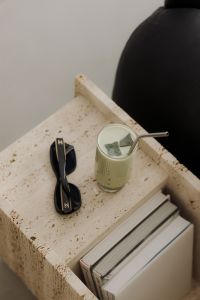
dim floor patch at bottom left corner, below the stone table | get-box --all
[0,259,36,300]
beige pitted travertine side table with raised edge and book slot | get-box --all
[0,75,200,300]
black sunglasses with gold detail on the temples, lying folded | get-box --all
[50,138,81,214]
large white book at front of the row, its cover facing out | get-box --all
[102,216,193,300]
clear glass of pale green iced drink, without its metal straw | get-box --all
[95,124,137,192]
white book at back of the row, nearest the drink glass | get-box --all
[80,191,170,295]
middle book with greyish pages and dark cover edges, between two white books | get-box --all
[92,201,178,299]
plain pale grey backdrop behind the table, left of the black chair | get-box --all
[0,0,164,149]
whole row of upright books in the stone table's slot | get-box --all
[80,191,193,300]
